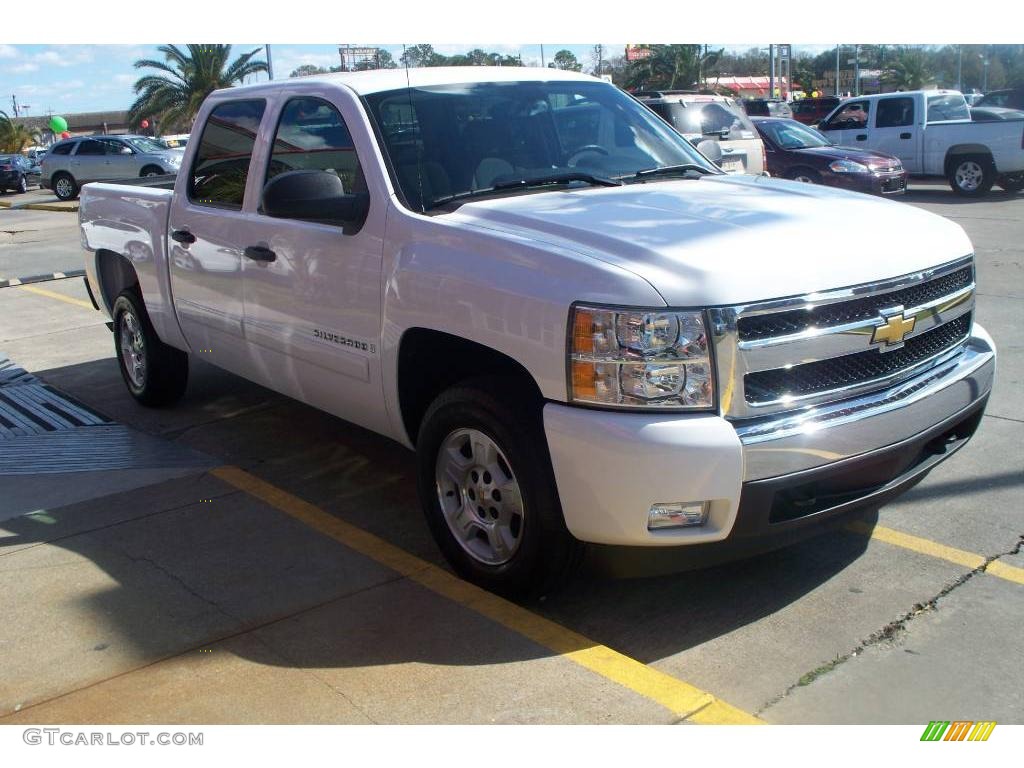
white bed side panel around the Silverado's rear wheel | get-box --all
[78,183,187,349]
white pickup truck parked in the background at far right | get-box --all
[818,90,1024,197]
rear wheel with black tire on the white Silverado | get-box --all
[113,286,188,407]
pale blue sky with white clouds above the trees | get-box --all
[0,43,831,115]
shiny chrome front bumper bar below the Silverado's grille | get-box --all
[735,324,995,482]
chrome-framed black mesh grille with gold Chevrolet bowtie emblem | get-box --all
[709,256,975,419]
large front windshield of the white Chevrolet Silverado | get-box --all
[366,81,713,211]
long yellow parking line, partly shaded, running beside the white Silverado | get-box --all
[213,467,763,725]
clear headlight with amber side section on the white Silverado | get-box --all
[569,306,715,410]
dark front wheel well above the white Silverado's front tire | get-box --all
[397,328,544,445]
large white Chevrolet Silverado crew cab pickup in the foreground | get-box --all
[79,68,995,593]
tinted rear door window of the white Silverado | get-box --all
[187,99,266,211]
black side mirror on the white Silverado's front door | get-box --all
[262,171,370,224]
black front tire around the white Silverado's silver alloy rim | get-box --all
[417,378,584,597]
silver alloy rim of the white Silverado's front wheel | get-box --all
[434,429,524,565]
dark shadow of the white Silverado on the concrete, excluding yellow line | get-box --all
[0,358,877,696]
